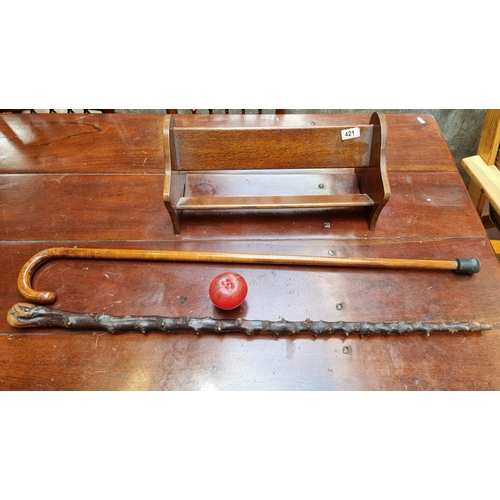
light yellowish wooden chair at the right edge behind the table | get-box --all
[460,109,500,258]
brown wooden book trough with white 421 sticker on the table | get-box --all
[163,113,390,234]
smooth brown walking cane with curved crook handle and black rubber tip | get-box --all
[17,247,481,304]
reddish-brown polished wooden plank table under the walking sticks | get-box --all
[0,114,500,390]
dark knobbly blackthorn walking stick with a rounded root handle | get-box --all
[7,303,492,337]
